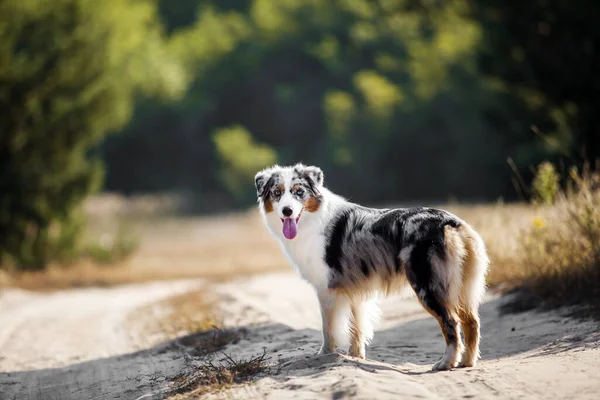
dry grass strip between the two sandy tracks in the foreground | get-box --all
[129,289,272,400]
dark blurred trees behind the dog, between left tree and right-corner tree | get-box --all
[102,0,546,206]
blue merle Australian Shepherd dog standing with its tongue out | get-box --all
[254,164,489,371]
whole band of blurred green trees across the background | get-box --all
[0,0,600,267]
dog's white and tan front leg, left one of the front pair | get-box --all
[317,290,349,354]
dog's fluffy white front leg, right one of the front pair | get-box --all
[349,299,379,359]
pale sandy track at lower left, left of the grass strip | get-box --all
[0,281,200,400]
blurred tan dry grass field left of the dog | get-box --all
[0,197,287,290]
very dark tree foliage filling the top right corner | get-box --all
[472,0,600,163]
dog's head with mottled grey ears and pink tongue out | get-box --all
[254,164,323,240]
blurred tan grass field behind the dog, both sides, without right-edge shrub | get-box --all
[0,196,538,290]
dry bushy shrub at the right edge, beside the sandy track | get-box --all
[520,162,600,306]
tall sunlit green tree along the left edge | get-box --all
[0,0,185,268]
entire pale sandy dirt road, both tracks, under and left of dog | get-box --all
[0,273,600,400]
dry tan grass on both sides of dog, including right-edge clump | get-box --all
[0,184,600,316]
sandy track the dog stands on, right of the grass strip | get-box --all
[214,274,600,399]
